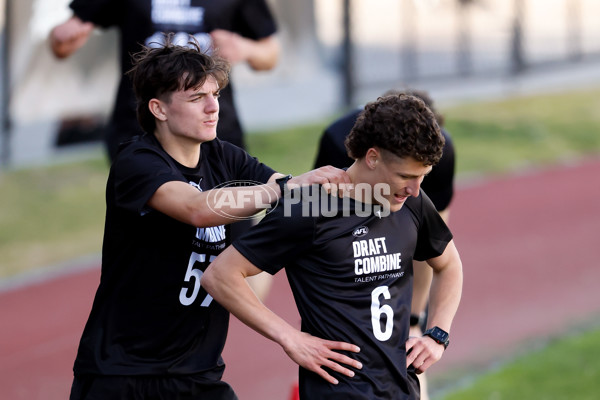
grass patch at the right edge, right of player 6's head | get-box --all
[445,89,600,174]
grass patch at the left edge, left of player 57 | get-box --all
[0,155,107,277]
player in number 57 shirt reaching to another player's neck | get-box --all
[70,35,349,400]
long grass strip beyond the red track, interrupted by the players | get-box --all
[0,89,600,279]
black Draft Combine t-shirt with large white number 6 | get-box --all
[233,191,452,400]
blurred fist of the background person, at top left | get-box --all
[50,15,94,58]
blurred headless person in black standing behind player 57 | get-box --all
[50,0,280,162]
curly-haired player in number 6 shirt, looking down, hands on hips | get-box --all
[203,95,462,400]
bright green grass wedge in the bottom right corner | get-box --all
[441,330,600,400]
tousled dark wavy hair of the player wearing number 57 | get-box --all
[127,33,230,133]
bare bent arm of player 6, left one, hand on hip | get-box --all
[202,246,362,384]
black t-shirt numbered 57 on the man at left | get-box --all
[74,135,274,379]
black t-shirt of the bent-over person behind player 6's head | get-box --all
[315,109,455,211]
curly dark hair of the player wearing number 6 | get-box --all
[345,94,444,165]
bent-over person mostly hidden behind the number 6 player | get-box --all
[315,89,455,400]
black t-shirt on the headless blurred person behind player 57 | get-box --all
[70,0,277,153]
